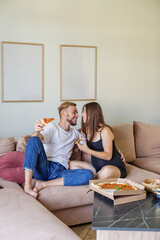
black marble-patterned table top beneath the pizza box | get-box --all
[92,192,160,231]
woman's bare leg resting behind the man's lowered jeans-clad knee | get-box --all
[69,161,96,176]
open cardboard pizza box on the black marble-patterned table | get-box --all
[89,178,146,205]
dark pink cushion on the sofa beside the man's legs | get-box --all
[0,151,24,184]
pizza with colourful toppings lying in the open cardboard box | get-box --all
[95,182,136,191]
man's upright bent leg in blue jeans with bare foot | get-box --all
[23,137,49,198]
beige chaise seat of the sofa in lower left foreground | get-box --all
[0,180,80,240]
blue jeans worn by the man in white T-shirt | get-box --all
[23,137,94,186]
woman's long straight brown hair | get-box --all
[81,102,110,141]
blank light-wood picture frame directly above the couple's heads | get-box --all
[60,45,97,101]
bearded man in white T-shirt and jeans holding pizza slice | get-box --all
[23,102,94,198]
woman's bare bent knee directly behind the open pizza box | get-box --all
[96,165,121,179]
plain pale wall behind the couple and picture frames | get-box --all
[0,0,160,139]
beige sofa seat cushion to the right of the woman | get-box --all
[126,163,160,184]
